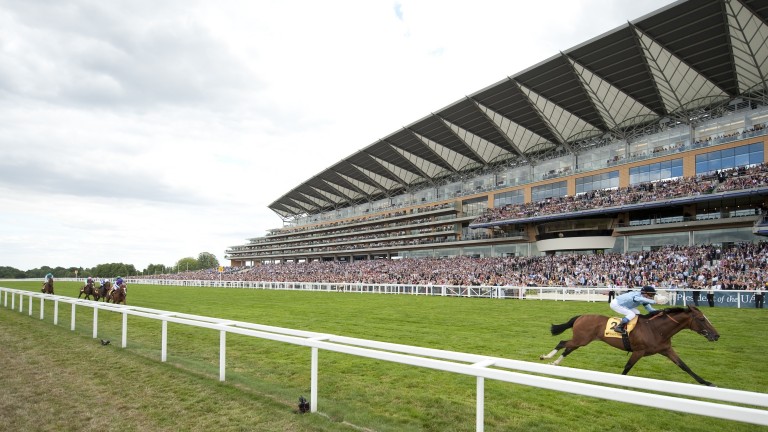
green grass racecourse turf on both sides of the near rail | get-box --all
[0,281,768,432]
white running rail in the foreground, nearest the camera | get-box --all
[0,287,768,431]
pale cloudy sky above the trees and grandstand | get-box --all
[0,0,671,271]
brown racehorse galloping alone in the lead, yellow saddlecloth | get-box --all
[539,306,720,386]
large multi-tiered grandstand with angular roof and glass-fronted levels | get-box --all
[227,0,768,266]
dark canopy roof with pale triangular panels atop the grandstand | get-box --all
[269,0,768,219]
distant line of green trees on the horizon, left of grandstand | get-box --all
[0,252,219,279]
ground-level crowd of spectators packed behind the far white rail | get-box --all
[138,242,768,289]
